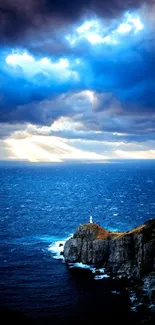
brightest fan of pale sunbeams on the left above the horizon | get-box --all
[5,136,107,162]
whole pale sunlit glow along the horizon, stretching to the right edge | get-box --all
[4,136,155,163]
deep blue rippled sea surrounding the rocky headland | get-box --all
[0,161,155,325]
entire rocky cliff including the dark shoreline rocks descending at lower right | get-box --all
[63,219,155,312]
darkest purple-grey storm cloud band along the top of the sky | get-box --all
[0,0,148,44]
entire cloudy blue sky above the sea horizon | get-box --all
[0,0,155,162]
